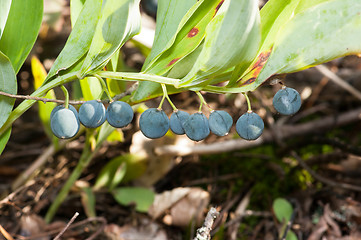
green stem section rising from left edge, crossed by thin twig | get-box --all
[0,72,78,136]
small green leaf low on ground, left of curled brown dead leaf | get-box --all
[112,187,155,212]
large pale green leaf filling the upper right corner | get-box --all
[254,0,361,87]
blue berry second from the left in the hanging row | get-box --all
[79,100,105,128]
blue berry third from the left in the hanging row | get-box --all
[106,101,134,128]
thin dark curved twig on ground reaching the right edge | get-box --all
[291,151,361,192]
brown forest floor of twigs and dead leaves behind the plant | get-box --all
[0,0,361,240]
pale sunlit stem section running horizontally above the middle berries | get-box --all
[97,71,180,88]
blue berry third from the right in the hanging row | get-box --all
[209,110,233,136]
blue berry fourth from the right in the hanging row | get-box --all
[183,113,210,141]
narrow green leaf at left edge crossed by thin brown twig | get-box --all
[0,52,17,127]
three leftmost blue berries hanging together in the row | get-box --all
[50,100,134,139]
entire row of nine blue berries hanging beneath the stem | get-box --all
[50,87,301,141]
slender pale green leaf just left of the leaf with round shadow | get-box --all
[45,0,102,83]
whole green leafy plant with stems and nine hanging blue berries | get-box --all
[0,0,361,221]
